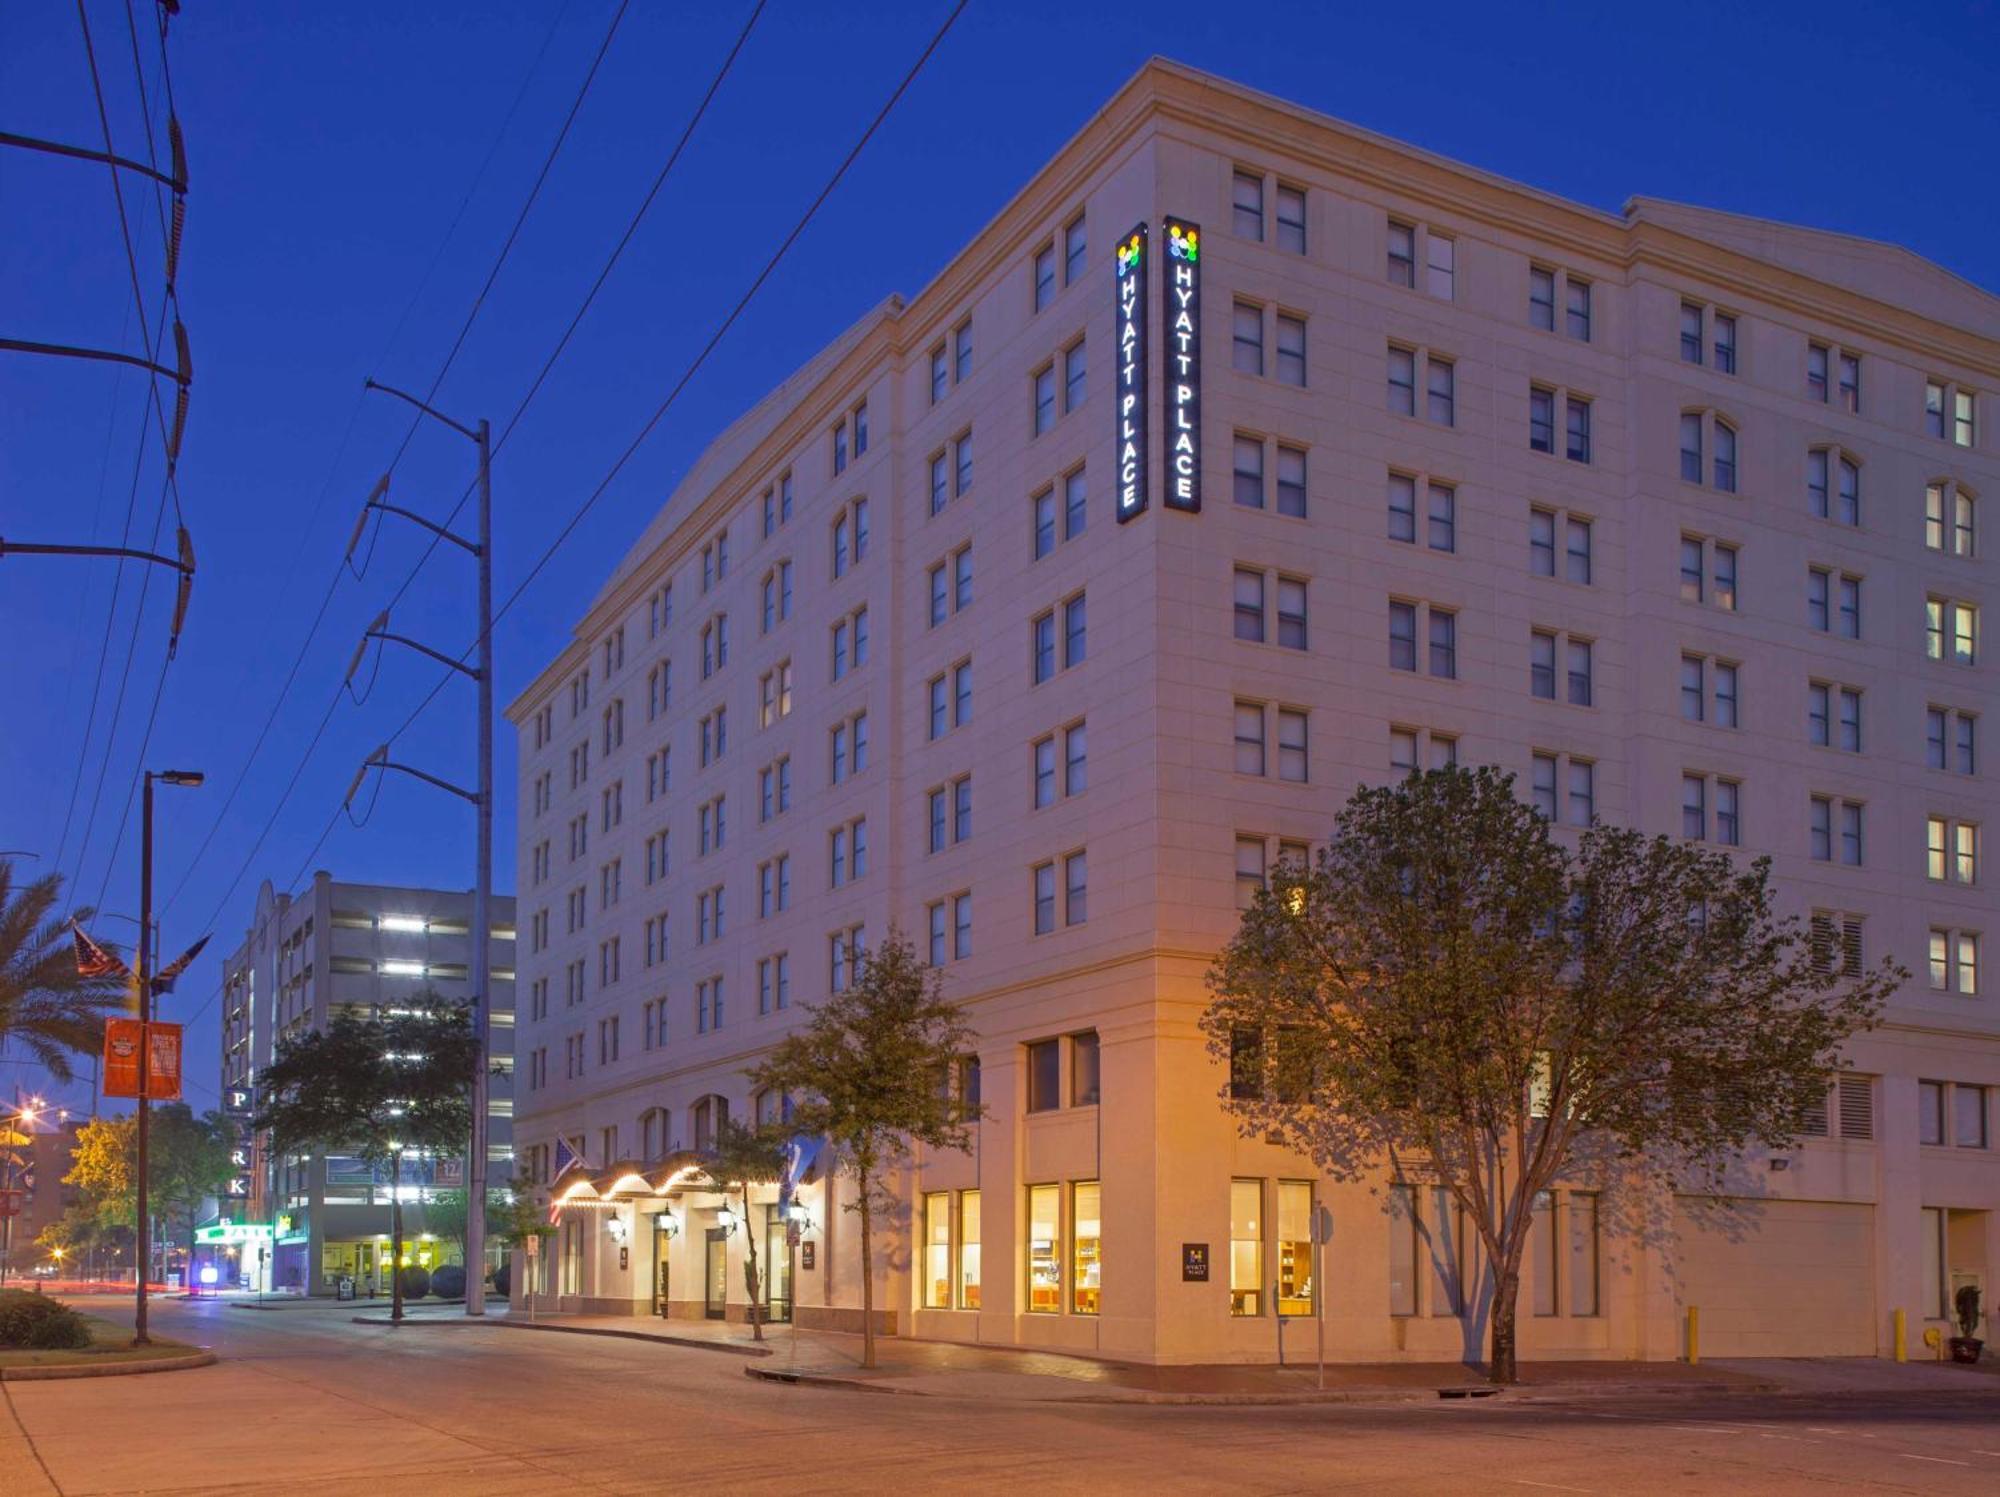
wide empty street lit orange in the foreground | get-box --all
[0,1303,2000,1497]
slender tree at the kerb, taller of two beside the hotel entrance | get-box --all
[748,927,982,1367]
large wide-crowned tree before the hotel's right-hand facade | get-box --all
[1202,769,1908,1383]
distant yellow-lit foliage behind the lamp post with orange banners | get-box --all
[64,1103,236,1251]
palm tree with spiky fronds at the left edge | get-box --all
[0,859,128,1081]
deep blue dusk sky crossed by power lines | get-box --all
[0,0,2000,1107]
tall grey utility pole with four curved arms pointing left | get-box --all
[348,378,494,1315]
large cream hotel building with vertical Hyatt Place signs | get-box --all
[510,62,2000,1363]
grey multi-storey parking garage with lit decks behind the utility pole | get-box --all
[221,873,514,1295]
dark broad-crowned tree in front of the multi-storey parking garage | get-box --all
[252,993,480,1323]
